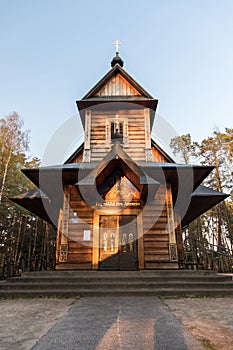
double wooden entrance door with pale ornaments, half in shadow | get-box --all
[99,215,138,270]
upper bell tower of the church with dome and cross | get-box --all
[77,45,158,162]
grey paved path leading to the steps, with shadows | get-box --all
[33,297,203,350]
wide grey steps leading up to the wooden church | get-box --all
[0,270,233,298]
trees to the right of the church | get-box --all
[171,128,233,272]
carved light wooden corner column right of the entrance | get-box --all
[166,184,178,262]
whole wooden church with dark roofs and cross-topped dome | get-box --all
[13,49,226,270]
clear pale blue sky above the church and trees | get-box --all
[0,0,233,158]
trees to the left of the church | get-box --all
[0,112,56,277]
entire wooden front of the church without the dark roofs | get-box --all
[57,63,182,270]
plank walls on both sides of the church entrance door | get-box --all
[58,185,178,270]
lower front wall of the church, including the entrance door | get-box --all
[57,186,181,270]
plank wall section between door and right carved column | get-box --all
[143,185,169,269]
